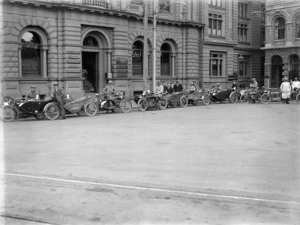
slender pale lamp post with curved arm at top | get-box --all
[152,1,186,92]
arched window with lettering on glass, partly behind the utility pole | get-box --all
[132,41,144,76]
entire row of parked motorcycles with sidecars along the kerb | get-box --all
[0,88,300,122]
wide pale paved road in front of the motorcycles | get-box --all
[0,104,300,224]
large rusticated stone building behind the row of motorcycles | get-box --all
[0,0,264,98]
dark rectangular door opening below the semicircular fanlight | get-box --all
[82,52,99,92]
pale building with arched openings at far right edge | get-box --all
[264,0,300,87]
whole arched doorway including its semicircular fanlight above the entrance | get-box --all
[81,31,111,92]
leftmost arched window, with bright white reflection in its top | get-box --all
[21,31,42,77]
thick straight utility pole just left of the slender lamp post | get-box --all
[143,0,150,90]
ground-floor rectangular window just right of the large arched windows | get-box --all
[209,52,225,77]
